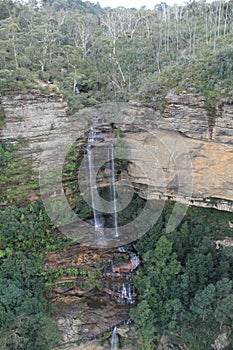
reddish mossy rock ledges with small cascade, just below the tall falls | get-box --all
[45,245,140,304]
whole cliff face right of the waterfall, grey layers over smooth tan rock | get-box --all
[112,95,233,211]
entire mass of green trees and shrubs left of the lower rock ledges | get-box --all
[0,202,70,350]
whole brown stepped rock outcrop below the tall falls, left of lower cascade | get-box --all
[45,245,137,349]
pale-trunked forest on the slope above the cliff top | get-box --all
[0,0,233,113]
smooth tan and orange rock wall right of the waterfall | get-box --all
[126,130,233,200]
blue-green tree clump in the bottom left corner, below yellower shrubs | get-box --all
[0,253,60,350]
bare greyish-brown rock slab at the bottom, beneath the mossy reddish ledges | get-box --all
[53,296,129,344]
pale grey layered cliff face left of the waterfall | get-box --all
[0,90,83,170]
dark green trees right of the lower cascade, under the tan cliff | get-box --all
[131,208,233,350]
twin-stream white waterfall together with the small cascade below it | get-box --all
[83,119,140,310]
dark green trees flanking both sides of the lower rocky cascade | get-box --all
[0,201,233,350]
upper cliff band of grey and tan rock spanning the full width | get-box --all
[0,91,233,210]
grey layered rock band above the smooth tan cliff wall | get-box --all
[116,93,233,144]
